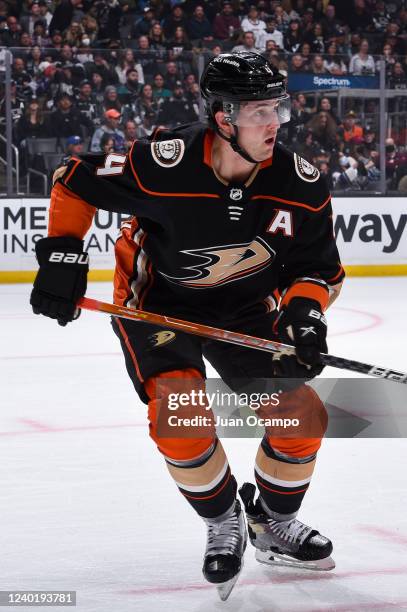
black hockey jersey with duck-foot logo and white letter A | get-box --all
[53,124,344,326]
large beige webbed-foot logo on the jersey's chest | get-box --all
[160,236,276,289]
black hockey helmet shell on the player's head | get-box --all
[201,51,287,104]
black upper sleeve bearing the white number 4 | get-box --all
[58,152,148,216]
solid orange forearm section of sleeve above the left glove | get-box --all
[48,183,96,240]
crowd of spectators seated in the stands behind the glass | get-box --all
[0,0,407,190]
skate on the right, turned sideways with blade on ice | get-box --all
[239,482,335,570]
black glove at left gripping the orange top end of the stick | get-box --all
[30,236,89,325]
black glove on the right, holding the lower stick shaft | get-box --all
[273,297,328,378]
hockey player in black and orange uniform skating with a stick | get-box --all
[31,52,344,599]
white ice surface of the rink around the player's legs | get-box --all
[0,278,407,612]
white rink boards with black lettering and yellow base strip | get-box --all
[0,196,407,283]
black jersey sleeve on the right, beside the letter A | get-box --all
[279,188,345,292]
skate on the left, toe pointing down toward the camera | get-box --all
[202,500,247,601]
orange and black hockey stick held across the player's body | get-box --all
[78,297,407,384]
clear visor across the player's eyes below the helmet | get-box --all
[223,94,291,127]
